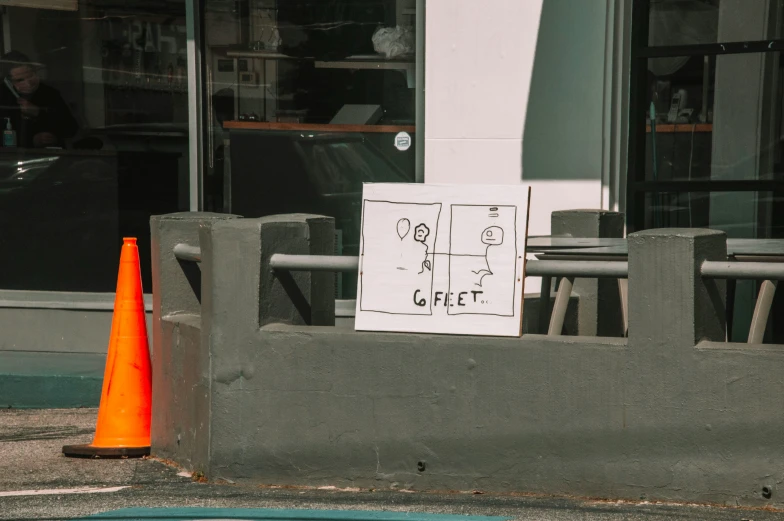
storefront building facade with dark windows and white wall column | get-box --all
[0,0,784,374]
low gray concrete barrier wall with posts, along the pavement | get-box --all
[152,215,784,506]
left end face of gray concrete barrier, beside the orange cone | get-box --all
[150,212,237,467]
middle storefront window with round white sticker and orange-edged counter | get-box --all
[203,0,423,298]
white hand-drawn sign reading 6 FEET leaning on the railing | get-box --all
[355,183,530,336]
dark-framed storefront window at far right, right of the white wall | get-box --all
[627,0,784,342]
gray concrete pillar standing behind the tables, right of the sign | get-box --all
[550,210,624,336]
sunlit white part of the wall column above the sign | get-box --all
[425,0,542,189]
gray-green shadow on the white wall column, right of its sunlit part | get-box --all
[522,0,607,181]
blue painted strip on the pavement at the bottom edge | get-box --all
[83,508,509,521]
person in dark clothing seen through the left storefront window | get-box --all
[0,51,78,148]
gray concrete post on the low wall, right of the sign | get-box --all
[628,229,727,351]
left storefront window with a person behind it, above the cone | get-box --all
[0,0,189,292]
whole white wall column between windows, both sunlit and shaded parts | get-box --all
[425,0,630,244]
